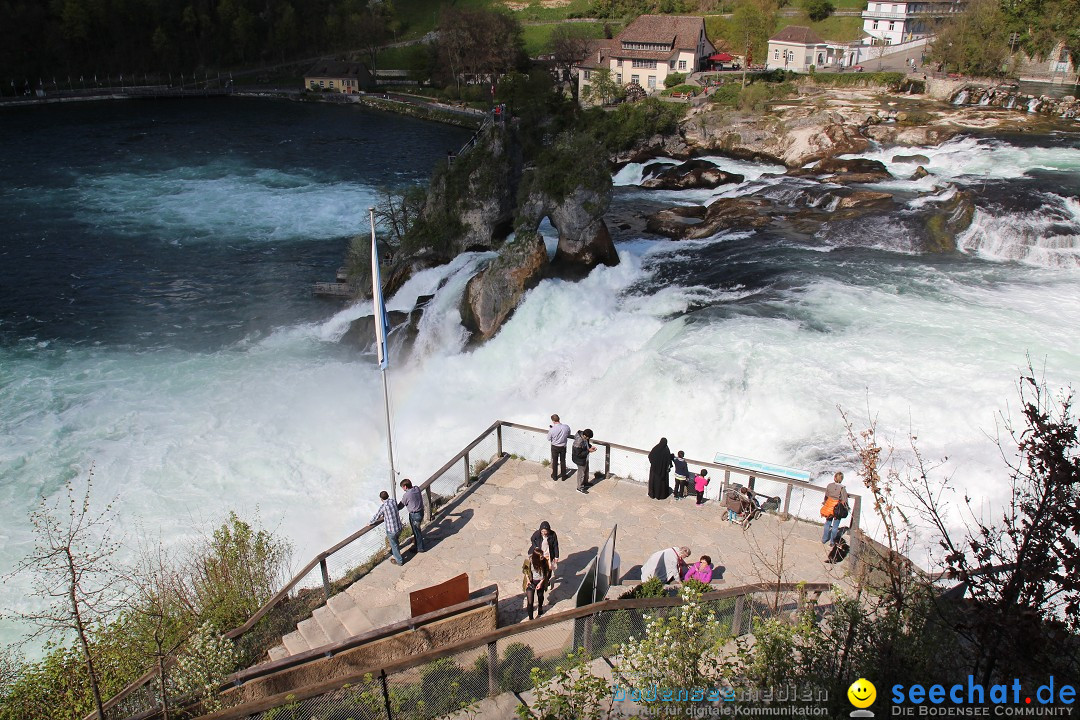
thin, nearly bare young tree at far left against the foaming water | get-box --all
[4,467,120,718]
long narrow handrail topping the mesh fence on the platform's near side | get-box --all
[200,583,833,720]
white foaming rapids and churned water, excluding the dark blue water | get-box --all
[0,131,1080,647]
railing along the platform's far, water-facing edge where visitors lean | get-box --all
[103,420,862,720]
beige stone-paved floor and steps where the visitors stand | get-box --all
[271,460,847,658]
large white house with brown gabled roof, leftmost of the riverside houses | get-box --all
[577,15,716,101]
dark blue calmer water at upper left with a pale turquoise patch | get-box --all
[0,98,469,349]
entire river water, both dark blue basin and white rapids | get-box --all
[0,99,1080,640]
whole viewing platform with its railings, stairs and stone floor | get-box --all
[97,421,865,720]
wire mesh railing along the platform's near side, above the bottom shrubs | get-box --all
[196,583,832,720]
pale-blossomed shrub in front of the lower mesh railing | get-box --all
[616,586,728,707]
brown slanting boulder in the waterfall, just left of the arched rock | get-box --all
[461,231,548,342]
